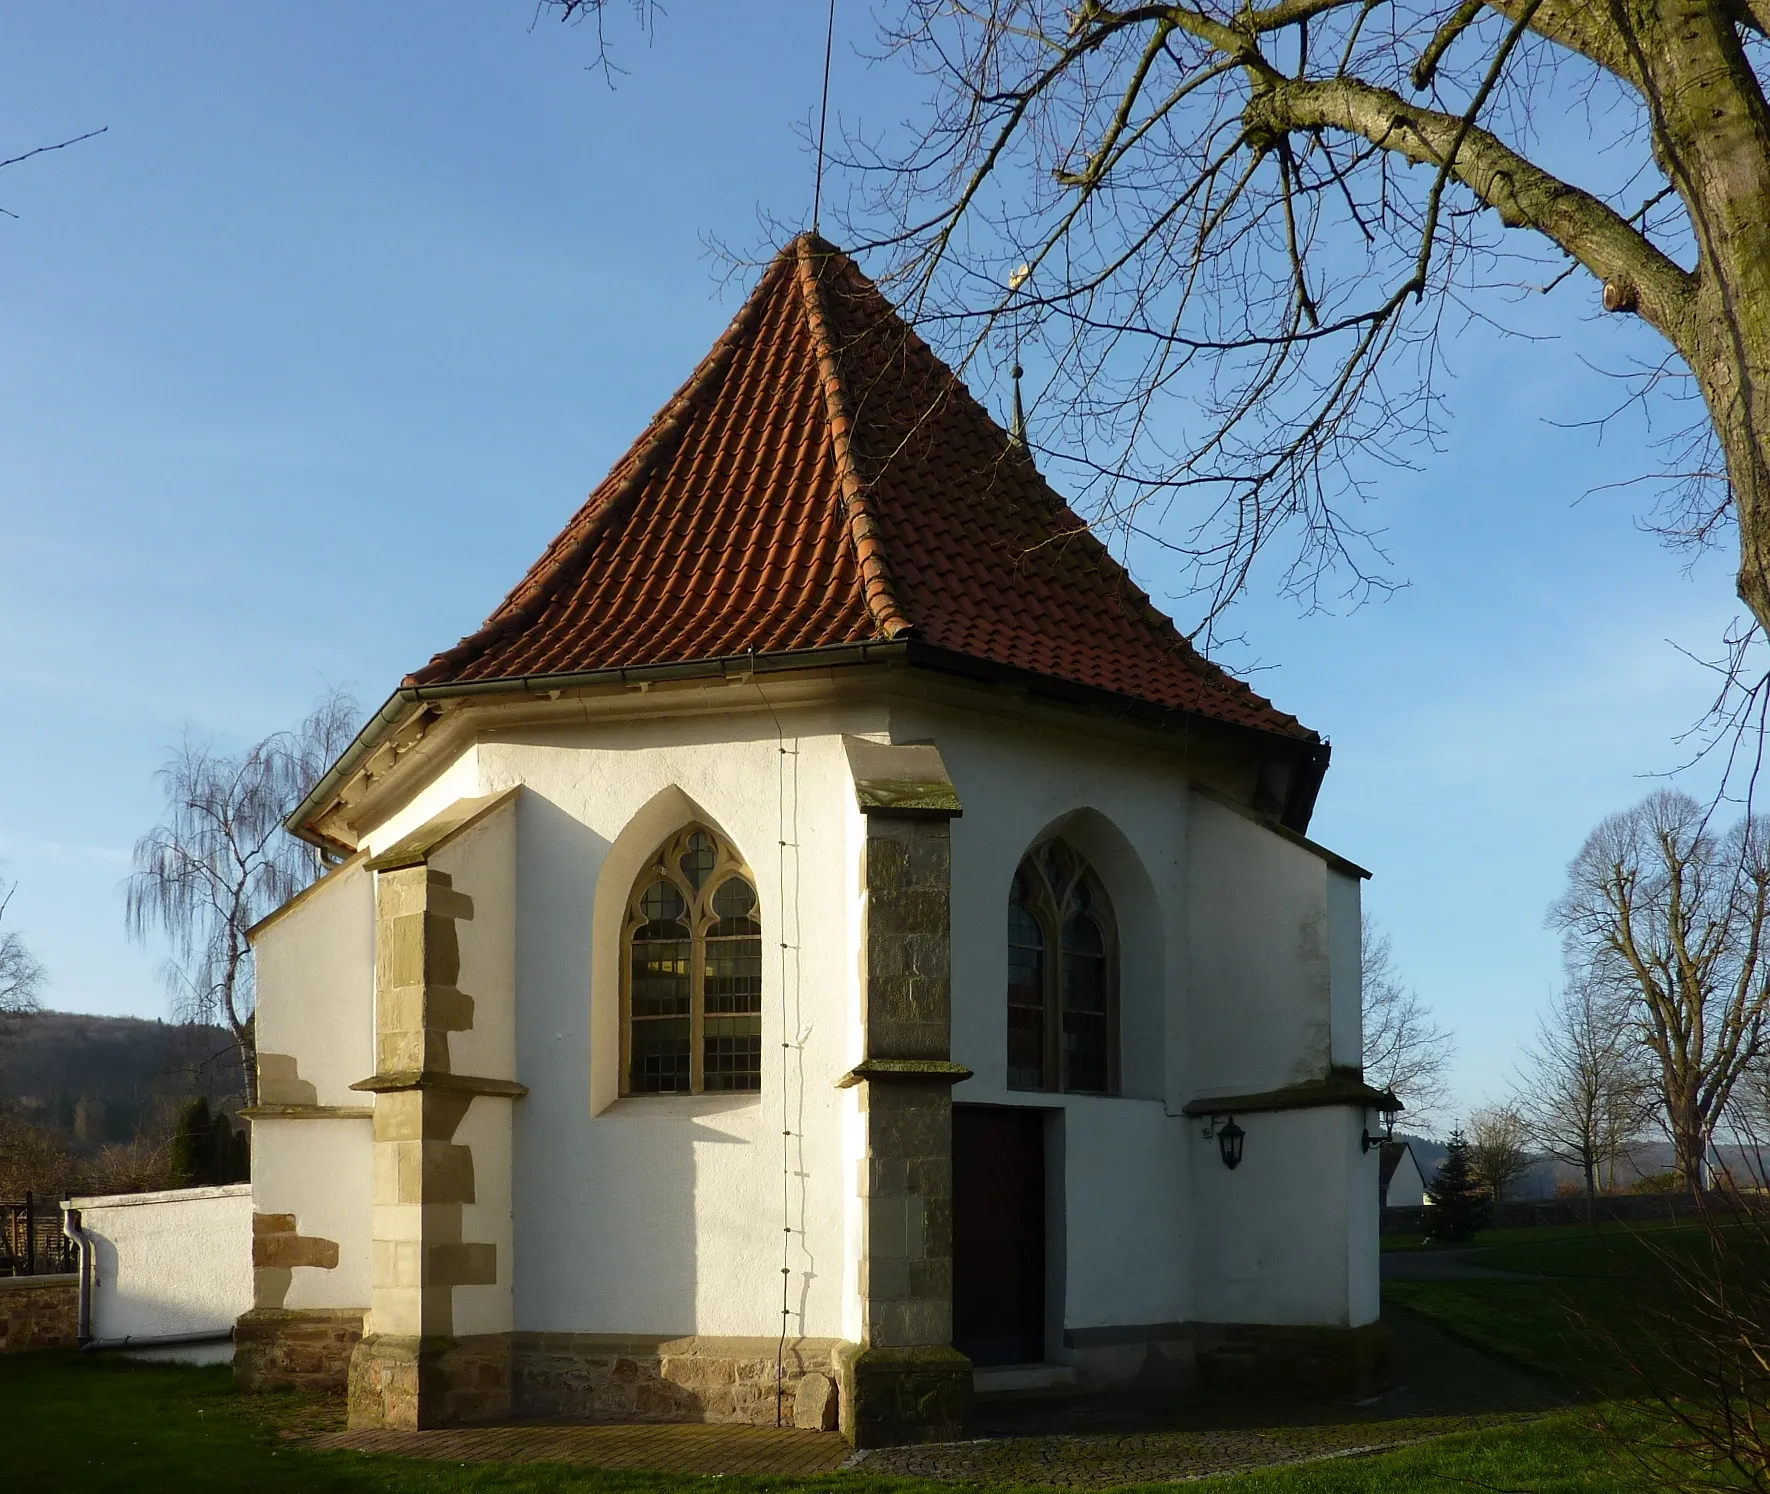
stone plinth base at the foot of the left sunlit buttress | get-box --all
[349,1333,512,1432]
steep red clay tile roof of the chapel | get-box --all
[405,235,1315,740]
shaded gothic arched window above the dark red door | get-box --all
[1007,841,1119,1094]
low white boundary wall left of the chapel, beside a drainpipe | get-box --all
[67,1182,251,1342]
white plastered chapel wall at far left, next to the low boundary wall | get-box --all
[248,862,375,1308]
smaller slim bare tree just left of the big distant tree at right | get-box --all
[1513,979,1651,1220]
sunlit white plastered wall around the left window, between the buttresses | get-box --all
[449,700,867,1336]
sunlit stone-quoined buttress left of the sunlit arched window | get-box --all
[349,795,526,1429]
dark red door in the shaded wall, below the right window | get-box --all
[952,1105,1044,1365]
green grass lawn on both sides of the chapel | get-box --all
[0,1225,1727,1494]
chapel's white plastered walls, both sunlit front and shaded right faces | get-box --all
[300,685,1377,1351]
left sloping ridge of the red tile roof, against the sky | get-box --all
[402,253,786,685]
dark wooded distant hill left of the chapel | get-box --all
[0,1011,244,1156]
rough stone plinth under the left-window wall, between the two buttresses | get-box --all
[512,1333,837,1430]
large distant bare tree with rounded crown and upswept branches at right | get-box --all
[1549,789,1770,1188]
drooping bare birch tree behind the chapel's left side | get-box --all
[126,690,358,1103]
